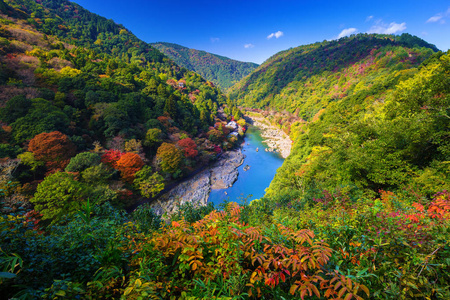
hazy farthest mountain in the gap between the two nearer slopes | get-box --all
[151,43,258,91]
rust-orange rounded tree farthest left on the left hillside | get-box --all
[28,131,76,171]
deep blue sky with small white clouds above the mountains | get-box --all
[73,0,450,64]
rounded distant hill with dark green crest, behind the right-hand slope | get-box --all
[232,34,438,119]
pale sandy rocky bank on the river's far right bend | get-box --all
[247,116,292,158]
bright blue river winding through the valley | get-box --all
[208,126,284,205]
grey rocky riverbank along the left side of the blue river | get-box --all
[150,148,244,215]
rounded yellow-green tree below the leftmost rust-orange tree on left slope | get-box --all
[30,172,90,221]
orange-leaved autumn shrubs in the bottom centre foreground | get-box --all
[124,203,369,299]
